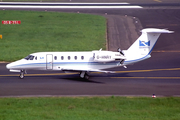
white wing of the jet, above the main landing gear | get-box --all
[61,68,115,73]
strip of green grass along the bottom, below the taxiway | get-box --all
[0,96,180,120]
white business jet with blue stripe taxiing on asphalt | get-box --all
[6,28,173,79]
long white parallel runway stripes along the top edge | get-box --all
[0,2,143,9]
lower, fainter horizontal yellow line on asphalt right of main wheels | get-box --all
[110,77,180,79]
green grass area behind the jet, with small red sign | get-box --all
[0,10,106,61]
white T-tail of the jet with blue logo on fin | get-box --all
[124,28,173,64]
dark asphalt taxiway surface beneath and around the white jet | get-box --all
[0,0,180,96]
